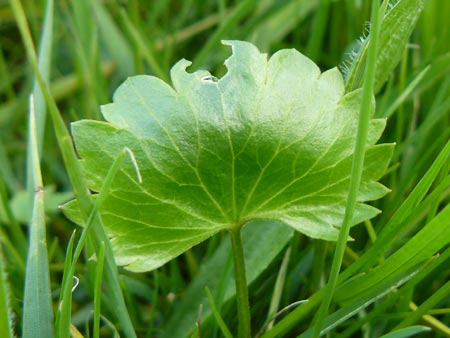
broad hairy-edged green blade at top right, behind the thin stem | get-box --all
[346,0,424,93]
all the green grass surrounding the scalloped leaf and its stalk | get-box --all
[0,0,450,338]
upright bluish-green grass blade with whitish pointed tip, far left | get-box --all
[22,95,54,338]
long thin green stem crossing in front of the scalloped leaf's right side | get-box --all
[313,0,386,338]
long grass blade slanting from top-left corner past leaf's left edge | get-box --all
[11,0,136,338]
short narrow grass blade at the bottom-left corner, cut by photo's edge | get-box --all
[0,233,14,338]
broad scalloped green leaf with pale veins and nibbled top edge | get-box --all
[66,41,393,271]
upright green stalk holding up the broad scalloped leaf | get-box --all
[230,225,251,338]
